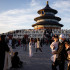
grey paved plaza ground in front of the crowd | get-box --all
[11,45,67,70]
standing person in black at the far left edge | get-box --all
[0,41,9,70]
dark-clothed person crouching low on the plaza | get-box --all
[11,52,23,68]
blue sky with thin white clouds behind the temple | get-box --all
[0,0,70,33]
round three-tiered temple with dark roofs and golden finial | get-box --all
[32,1,63,29]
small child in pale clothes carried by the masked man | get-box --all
[50,35,59,62]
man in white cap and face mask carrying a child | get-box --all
[52,34,67,70]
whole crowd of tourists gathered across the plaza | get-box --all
[0,34,70,70]
